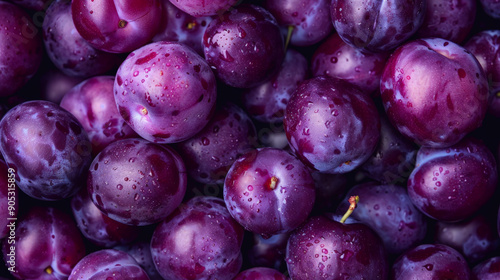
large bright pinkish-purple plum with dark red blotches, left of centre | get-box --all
[114,41,217,144]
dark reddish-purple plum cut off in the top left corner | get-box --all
[0,1,43,97]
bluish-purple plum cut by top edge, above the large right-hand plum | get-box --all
[330,0,427,52]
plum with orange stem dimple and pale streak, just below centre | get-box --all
[224,148,315,236]
